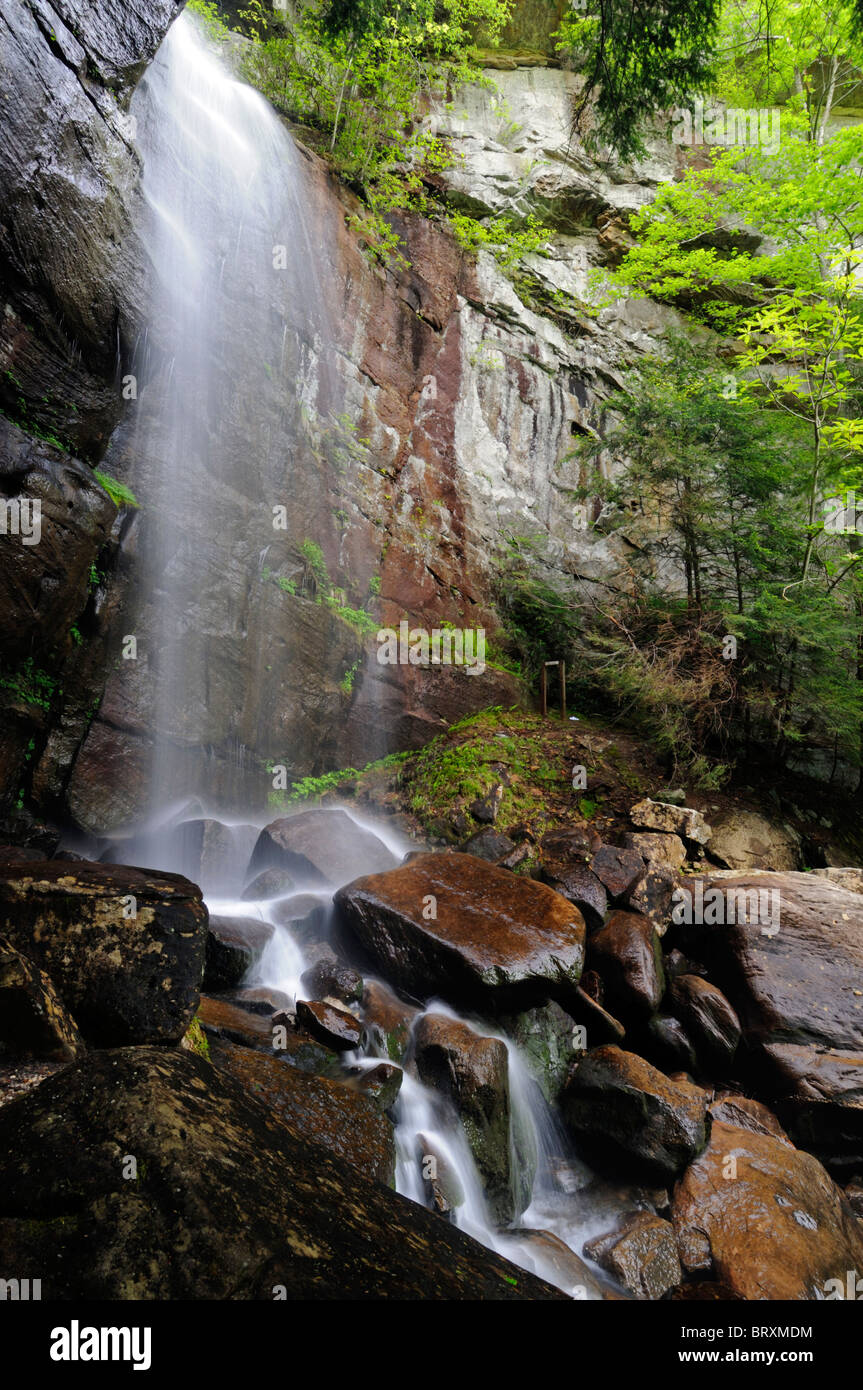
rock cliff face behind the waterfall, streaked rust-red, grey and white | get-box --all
[0,0,675,833]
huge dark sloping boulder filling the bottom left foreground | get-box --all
[0,1048,563,1301]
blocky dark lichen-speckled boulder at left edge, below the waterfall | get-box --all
[0,862,207,1047]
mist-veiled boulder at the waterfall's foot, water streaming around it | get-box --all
[249,808,396,884]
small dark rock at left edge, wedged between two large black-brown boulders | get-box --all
[0,937,83,1062]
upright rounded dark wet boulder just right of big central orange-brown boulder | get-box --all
[588,912,666,1017]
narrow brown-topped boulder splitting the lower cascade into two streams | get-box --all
[414,1013,531,1222]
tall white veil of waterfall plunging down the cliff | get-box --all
[119,15,331,867]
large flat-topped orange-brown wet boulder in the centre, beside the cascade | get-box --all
[335,853,585,1009]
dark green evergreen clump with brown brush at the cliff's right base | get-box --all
[572,339,863,785]
